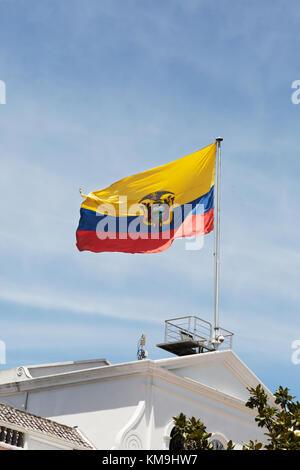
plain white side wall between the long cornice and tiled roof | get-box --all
[27,377,149,449]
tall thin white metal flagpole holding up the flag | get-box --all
[214,137,223,347]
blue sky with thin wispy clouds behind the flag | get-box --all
[0,0,300,395]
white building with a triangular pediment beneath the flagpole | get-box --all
[0,350,272,450]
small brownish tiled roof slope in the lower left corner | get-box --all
[0,403,93,449]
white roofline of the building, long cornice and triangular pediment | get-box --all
[0,350,273,416]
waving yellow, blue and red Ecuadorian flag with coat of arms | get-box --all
[76,142,217,253]
